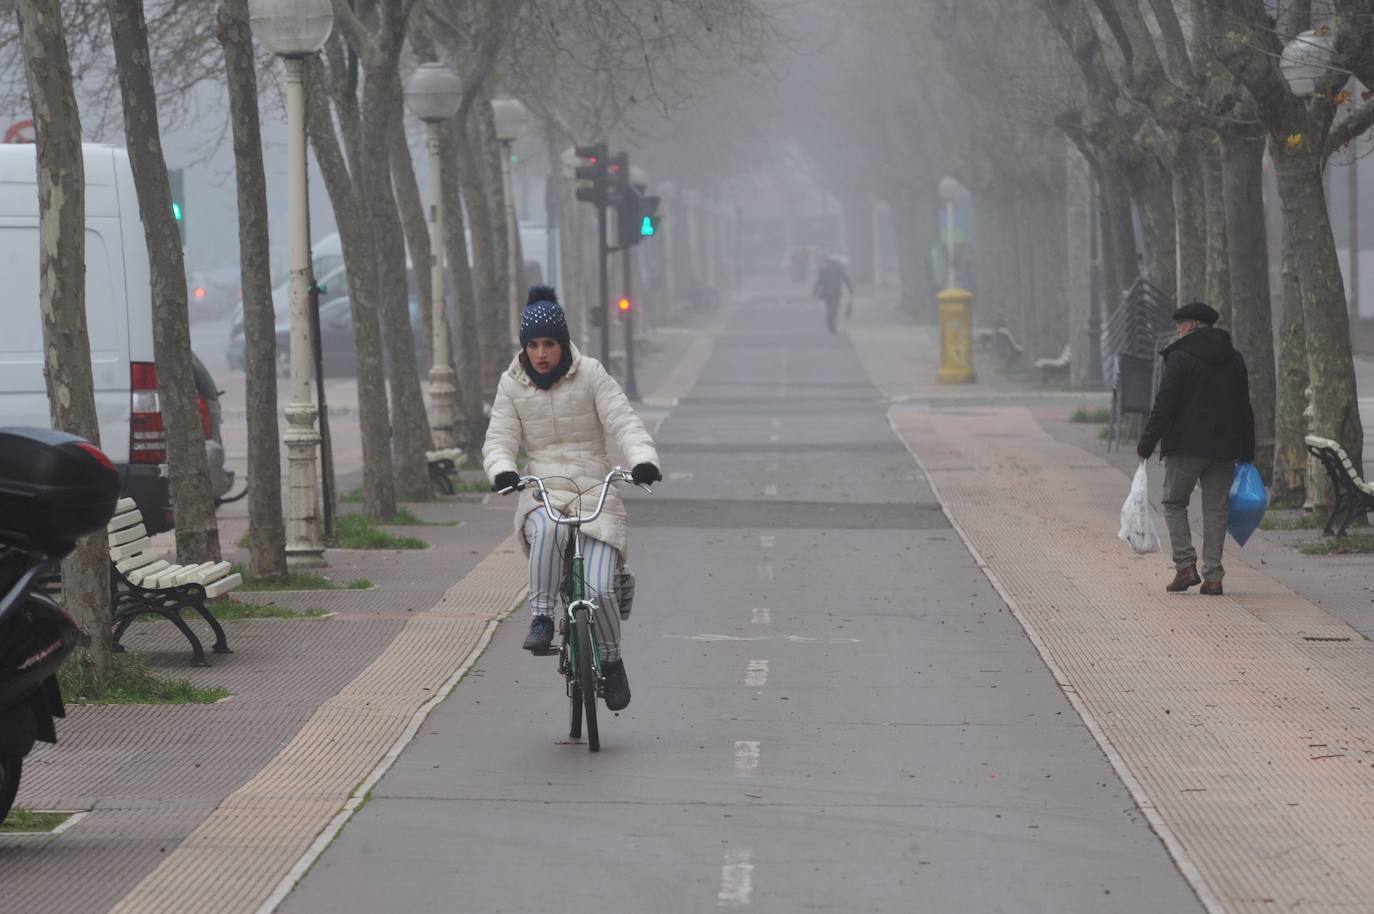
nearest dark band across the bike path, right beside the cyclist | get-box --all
[627,498,949,531]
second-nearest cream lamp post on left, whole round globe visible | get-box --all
[405,63,463,448]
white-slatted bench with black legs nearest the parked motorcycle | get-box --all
[107,499,243,667]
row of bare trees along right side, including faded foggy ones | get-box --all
[793,0,1374,504]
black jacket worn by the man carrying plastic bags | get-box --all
[1135,326,1254,463]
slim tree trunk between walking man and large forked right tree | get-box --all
[1270,222,1309,507]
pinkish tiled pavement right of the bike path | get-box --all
[852,302,1374,911]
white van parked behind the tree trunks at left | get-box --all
[0,144,182,532]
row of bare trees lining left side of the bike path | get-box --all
[13,0,768,667]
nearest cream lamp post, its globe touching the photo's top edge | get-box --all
[249,0,334,566]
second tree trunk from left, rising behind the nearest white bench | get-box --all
[106,0,220,564]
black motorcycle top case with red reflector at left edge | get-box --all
[0,427,120,550]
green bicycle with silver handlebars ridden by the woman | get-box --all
[502,466,653,752]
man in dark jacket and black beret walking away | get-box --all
[1135,301,1254,595]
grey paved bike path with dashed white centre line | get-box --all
[280,298,1200,914]
